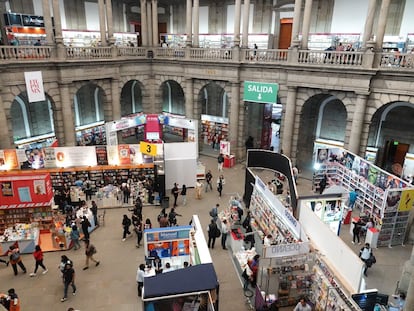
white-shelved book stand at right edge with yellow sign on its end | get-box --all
[313,148,414,246]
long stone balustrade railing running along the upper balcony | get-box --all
[0,46,414,70]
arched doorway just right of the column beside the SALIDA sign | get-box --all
[296,94,347,174]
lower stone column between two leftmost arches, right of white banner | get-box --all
[59,83,76,146]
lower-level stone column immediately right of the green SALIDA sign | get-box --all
[280,86,297,157]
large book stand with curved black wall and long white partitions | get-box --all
[243,150,363,311]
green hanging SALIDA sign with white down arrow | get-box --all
[243,81,279,104]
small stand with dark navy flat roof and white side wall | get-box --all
[142,215,219,311]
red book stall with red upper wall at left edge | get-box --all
[0,174,53,254]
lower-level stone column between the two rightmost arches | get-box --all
[348,94,368,154]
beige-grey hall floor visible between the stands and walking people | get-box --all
[0,156,412,311]
